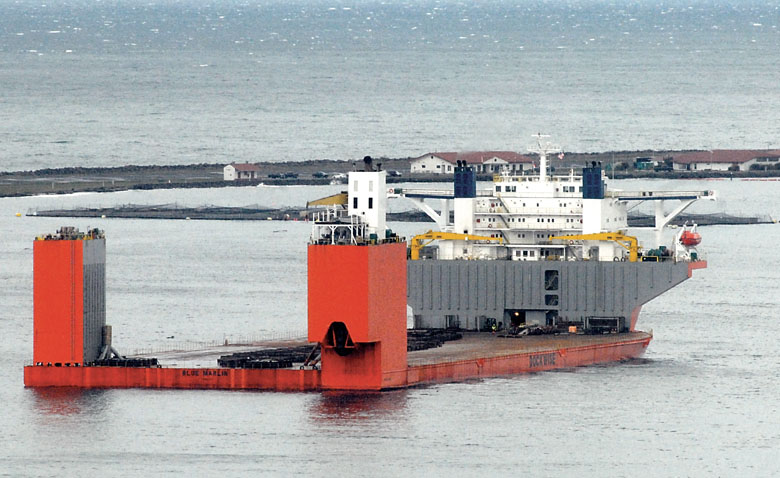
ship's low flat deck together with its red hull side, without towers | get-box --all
[24,332,652,391]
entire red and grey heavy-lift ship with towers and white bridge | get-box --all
[24,136,708,391]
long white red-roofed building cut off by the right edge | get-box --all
[672,149,780,171]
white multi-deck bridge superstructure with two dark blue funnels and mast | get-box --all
[401,135,714,261]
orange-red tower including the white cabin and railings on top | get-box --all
[308,160,407,390]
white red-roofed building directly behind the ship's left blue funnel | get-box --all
[411,151,534,174]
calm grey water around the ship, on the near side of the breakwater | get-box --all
[0,177,780,477]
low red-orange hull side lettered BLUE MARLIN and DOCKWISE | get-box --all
[24,332,652,392]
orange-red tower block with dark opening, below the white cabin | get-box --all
[308,242,407,390]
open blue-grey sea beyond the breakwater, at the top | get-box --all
[0,0,780,170]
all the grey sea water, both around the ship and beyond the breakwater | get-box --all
[0,0,780,477]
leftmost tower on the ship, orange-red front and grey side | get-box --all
[33,227,106,366]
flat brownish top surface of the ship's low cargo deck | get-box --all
[133,332,651,368]
